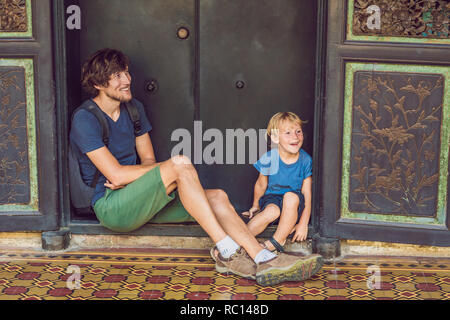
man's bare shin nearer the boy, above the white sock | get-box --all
[206,189,272,259]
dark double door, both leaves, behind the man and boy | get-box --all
[66,0,317,215]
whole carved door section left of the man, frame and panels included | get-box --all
[0,0,58,231]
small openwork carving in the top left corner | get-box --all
[0,0,28,32]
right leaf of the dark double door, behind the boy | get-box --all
[199,0,317,211]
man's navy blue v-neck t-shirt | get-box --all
[70,99,152,206]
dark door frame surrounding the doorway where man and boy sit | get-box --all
[52,0,327,239]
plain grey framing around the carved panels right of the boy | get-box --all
[319,0,450,246]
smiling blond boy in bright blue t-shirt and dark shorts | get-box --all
[243,112,312,252]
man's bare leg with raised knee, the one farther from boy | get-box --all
[159,156,229,243]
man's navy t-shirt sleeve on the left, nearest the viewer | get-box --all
[70,110,105,153]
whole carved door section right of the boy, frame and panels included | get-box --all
[320,0,450,245]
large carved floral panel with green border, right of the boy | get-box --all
[341,63,450,225]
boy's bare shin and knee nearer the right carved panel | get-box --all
[266,192,300,249]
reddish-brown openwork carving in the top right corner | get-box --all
[353,0,450,39]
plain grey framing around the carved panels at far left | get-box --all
[0,0,60,232]
